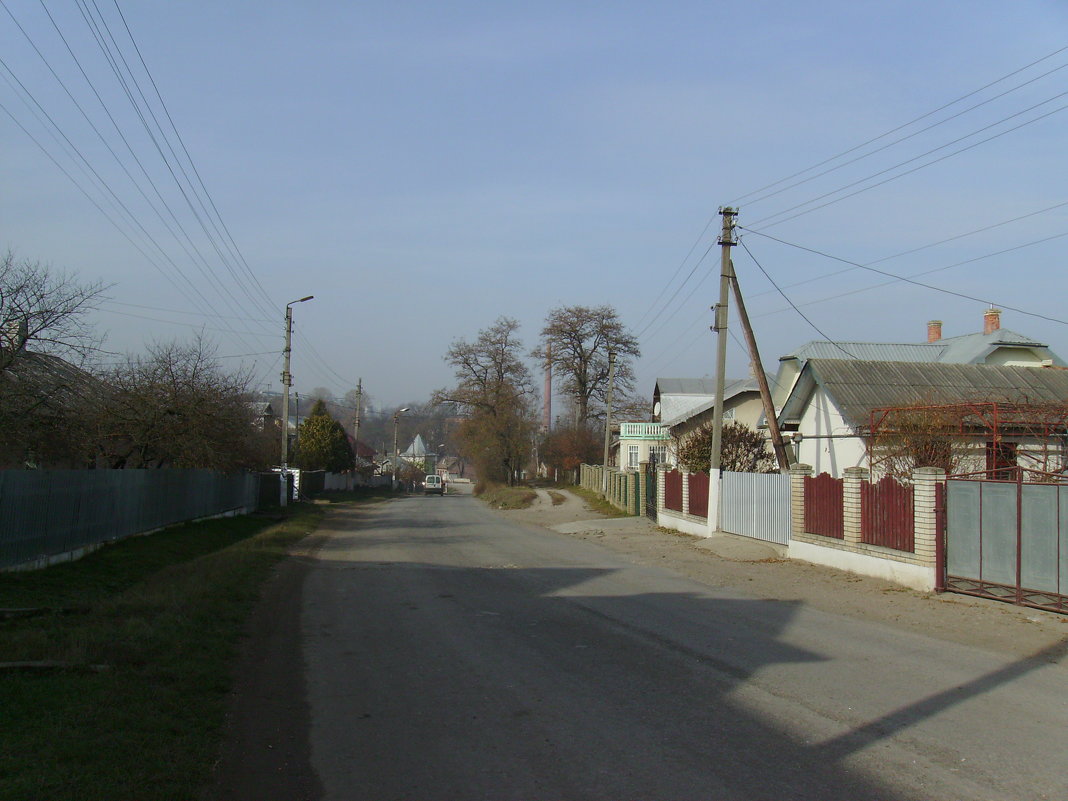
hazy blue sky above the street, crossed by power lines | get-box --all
[0,0,1068,406]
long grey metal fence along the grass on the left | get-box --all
[0,470,258,569]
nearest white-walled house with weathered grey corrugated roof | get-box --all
[779,360,1068,477]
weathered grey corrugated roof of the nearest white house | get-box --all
[780,359,1068,428]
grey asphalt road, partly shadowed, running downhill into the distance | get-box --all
[216,496,1068,801]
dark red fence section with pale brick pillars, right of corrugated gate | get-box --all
[789,465,945,591]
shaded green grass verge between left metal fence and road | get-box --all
[0,504,323,801]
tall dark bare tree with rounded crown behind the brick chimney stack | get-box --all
[534,305,641,425]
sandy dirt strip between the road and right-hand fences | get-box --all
[497,490,1068,657]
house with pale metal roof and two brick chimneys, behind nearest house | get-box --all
[771,309,1065,409]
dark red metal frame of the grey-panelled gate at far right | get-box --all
[936,467,1068,613]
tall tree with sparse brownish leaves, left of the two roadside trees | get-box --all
[434,317,535,484]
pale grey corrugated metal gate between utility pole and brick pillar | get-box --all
[720,472,790,545]
